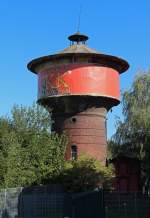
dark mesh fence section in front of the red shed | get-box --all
[104,192,150,218]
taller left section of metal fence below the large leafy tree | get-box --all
[0,185,66,218]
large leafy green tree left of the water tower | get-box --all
[0,104,67,187]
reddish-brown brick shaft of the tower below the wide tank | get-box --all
[53,107,107,163]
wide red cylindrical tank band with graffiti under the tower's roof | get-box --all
[38,64,120,101]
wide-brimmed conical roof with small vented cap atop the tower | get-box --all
[27,32,129,73]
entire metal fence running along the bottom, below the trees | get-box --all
[0,185,150,218]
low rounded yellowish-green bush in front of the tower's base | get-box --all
[55,156,114,192]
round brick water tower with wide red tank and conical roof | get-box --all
[28,32,129,162]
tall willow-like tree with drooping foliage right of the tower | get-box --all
[109,72,150,189]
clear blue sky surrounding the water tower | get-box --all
[0,0,150,138]
